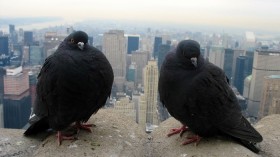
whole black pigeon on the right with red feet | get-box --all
[158,40,263,153]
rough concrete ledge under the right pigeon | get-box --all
[151,115,280,157]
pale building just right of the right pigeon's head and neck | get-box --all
[208,46,225,69]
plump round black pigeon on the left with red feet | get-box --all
[24,31,114,145]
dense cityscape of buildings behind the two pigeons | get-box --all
[0,21,280,132]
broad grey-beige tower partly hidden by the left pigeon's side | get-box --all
[102,30,127,92]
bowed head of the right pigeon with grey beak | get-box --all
[176,40,200,67]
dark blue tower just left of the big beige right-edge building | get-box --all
[233,56,249,95]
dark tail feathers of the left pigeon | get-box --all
[24,117,50,136]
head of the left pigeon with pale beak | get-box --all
[68,31,88,50]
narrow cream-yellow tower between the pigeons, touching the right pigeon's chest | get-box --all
[143,60,159,132]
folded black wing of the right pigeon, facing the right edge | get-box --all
[193,63,262,142]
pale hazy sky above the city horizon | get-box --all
[0,0,280,32]
